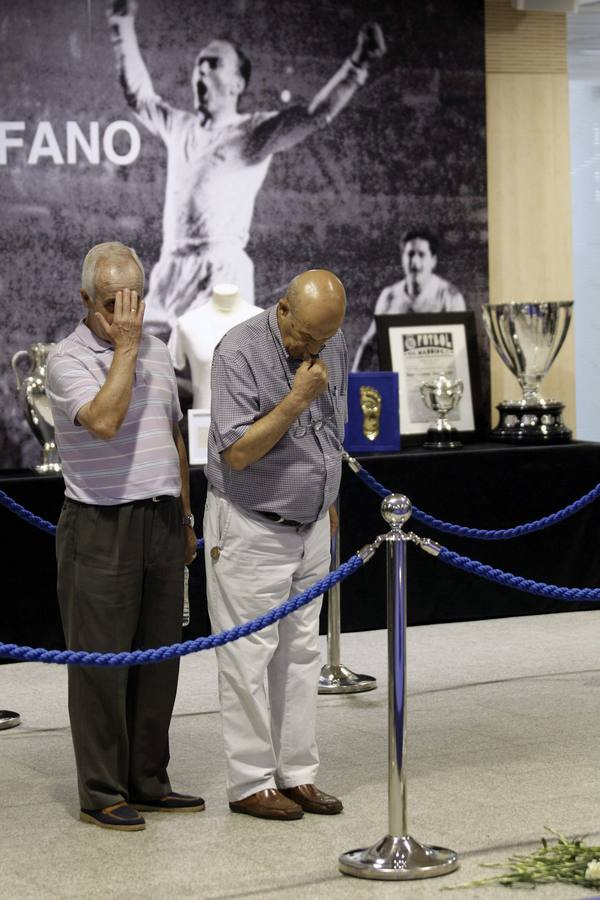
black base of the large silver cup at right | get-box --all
[491,400,573,444]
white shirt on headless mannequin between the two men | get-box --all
[169,284,263,409]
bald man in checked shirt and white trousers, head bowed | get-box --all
[204,269,348,820]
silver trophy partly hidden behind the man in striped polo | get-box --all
[11,343,61,475]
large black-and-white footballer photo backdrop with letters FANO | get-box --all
[0,0,487,468]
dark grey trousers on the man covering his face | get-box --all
[56,498,184,809]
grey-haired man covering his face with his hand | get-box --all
[47,243,204,831]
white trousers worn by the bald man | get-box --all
[204,488,331,801]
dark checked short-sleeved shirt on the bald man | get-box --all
[206,307,348,523]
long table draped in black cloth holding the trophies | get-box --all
[0,442,600,649]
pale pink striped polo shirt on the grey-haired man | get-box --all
[46,321,181,506]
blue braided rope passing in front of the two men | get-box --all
[0,554,363,666]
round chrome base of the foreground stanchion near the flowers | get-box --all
[339,834,458,881]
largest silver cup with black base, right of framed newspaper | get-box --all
[482,300,573,444]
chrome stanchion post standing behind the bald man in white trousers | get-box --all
[318,500,377,694]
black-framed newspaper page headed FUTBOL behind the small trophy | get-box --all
[375,312,483,446]
